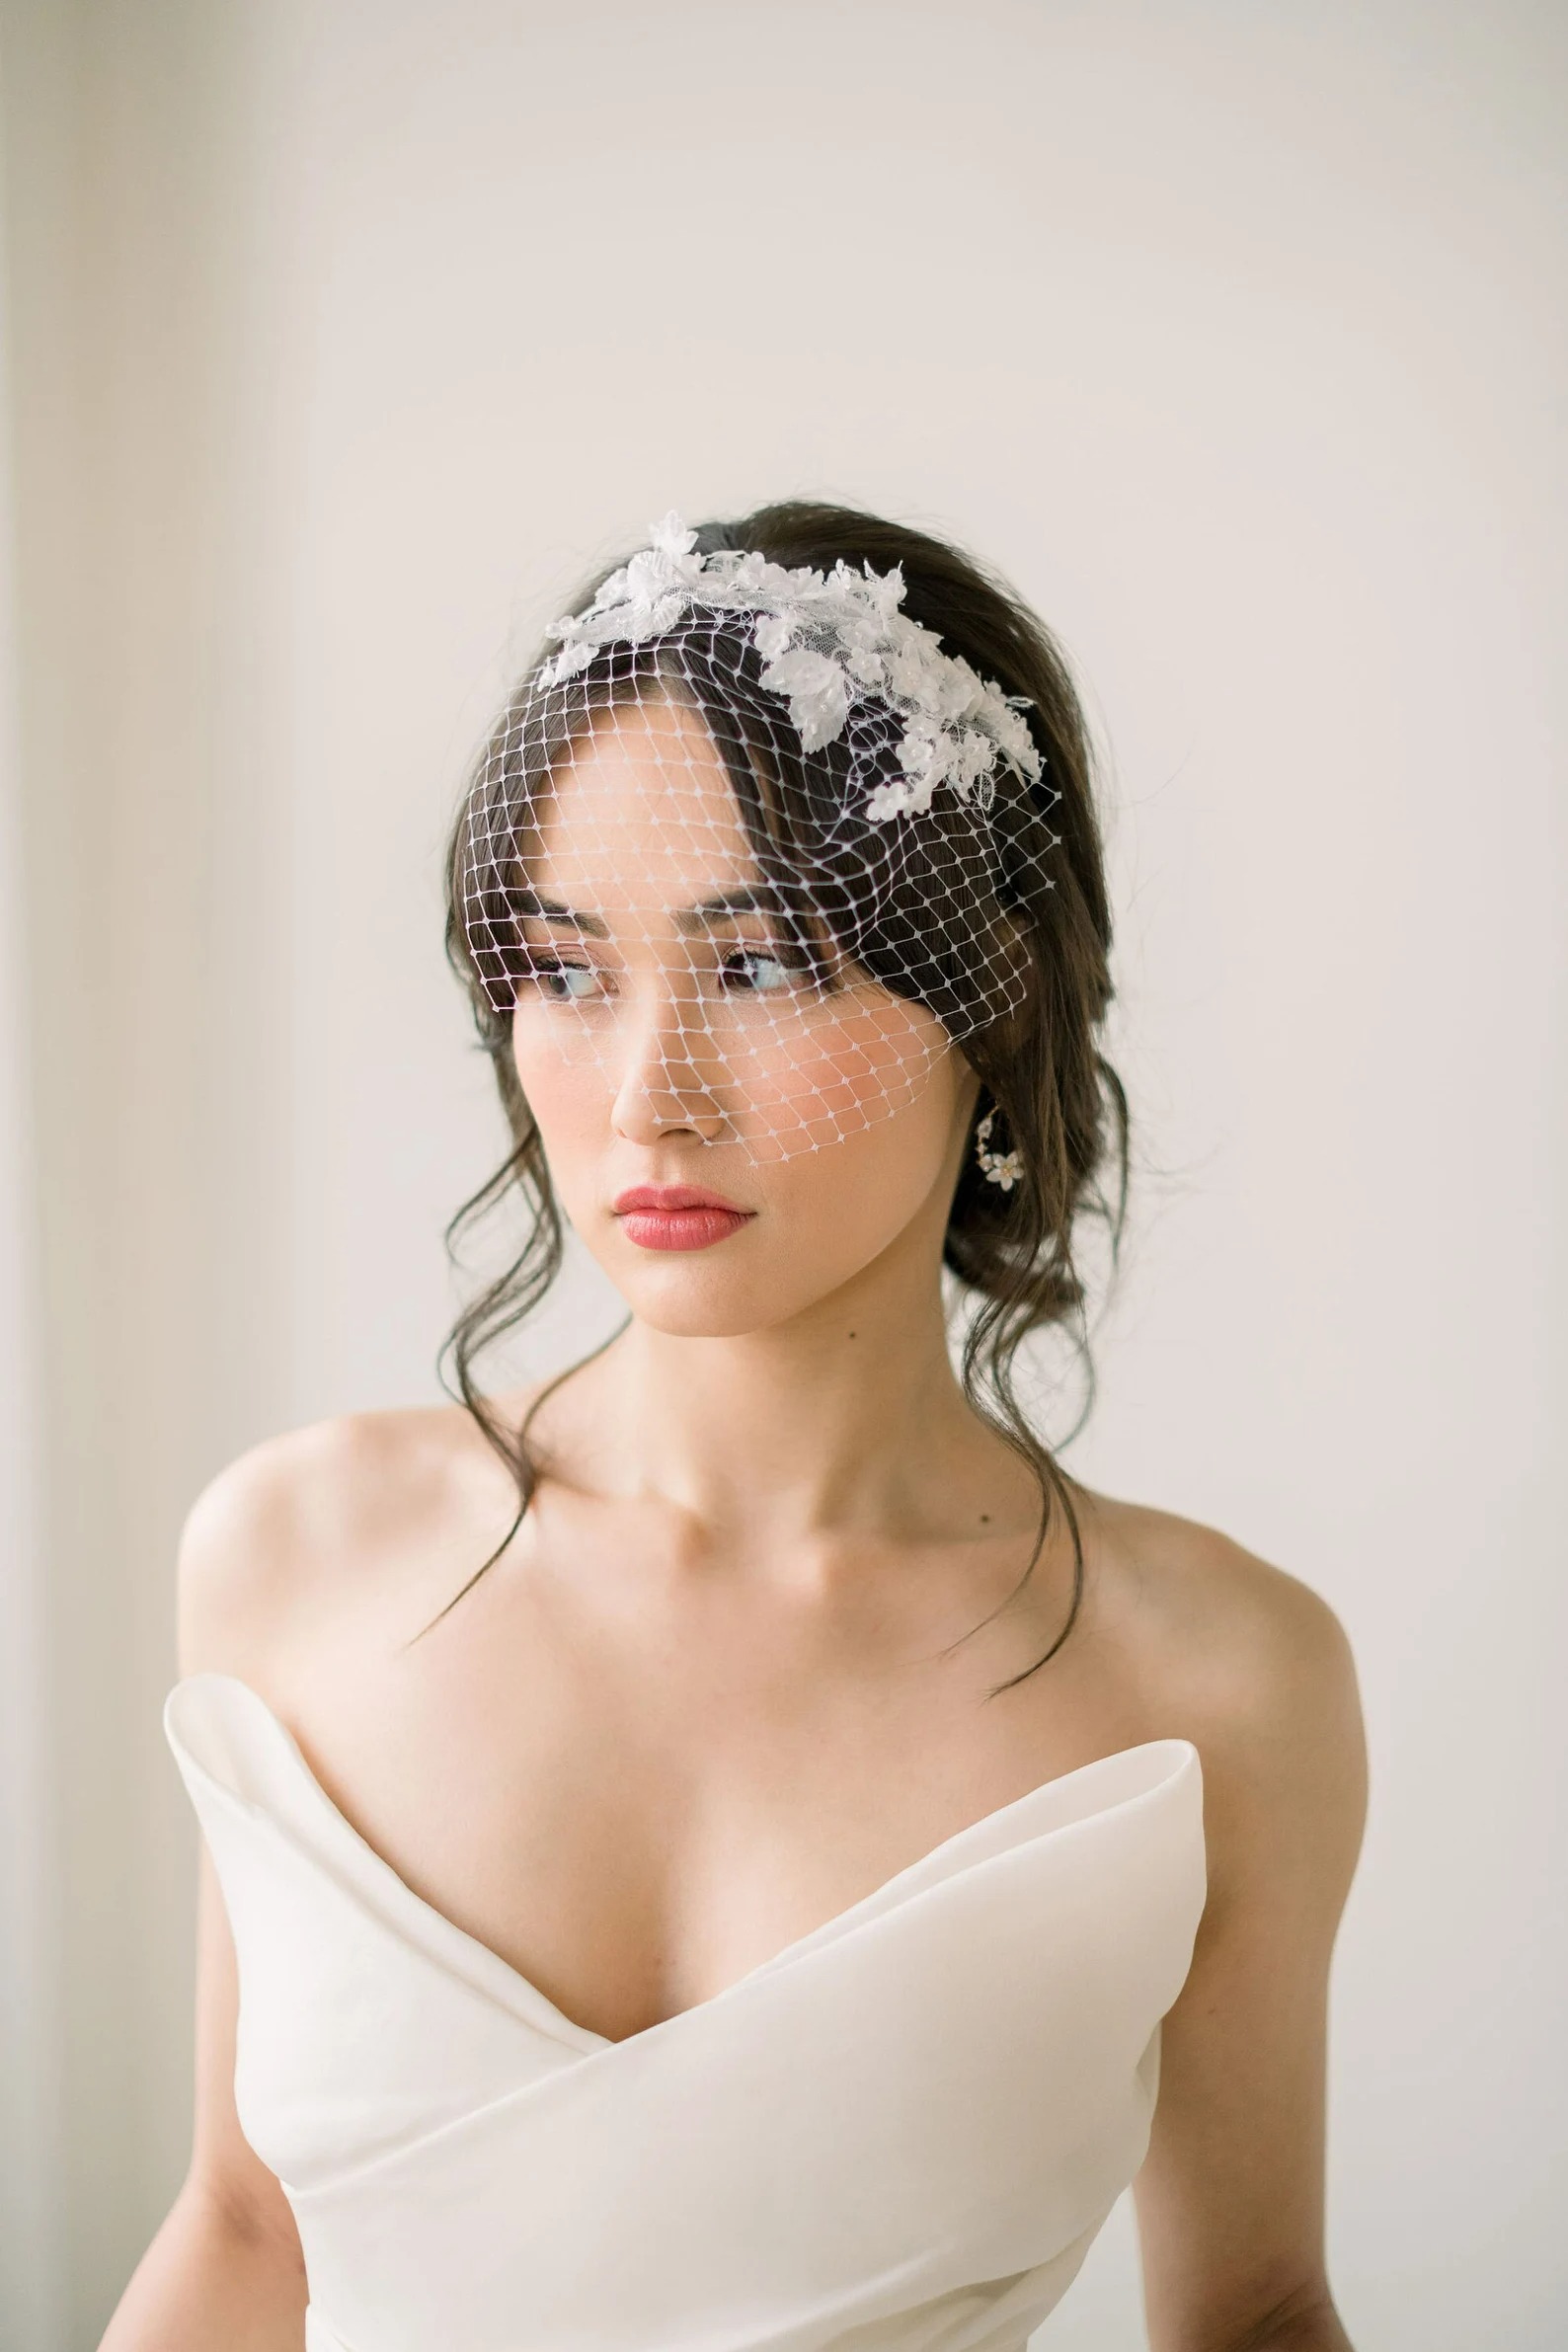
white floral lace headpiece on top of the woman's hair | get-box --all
[538,512,1042,823]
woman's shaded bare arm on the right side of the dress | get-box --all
[1136,1571,1366,2352]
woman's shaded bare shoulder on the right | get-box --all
[1093,1496,1366,1894]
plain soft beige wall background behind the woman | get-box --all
[0,0,1568,2352]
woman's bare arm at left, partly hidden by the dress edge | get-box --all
[101,1460,306,2352]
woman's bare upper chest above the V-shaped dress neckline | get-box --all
[271,1495,1147,2039]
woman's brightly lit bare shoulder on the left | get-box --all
[179,1399,535,1680]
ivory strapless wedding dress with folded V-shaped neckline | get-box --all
[165,1675,1204,2352]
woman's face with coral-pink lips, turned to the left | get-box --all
[512,701,978,1336]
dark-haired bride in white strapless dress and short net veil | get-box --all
[104,504,1364,2352]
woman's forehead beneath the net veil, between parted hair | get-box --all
[526,696,757,907]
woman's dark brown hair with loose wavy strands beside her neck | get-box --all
[425,501,1129,1688]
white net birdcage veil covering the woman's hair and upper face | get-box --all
[463,534,1056,1159]
